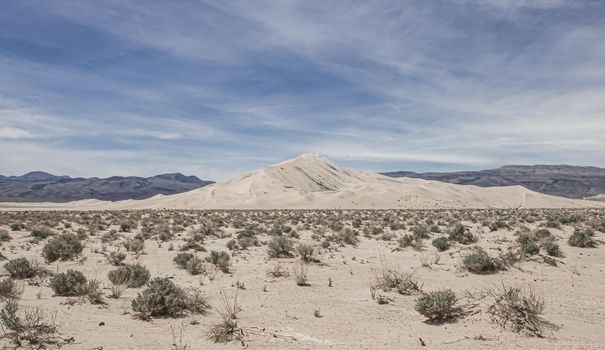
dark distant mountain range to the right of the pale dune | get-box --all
[382,165,605,199]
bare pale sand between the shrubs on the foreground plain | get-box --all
[2,209,605,349]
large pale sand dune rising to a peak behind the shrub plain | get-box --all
[1,154,603,209]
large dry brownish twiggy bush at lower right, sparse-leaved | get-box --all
[487,283,555,337]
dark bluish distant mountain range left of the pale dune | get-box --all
[0,171,214,202]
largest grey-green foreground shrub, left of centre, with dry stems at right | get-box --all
[132,277,209,320]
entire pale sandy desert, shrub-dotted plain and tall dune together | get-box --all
[0,154,605,349]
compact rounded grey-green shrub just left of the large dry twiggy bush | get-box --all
[415,289,462,322]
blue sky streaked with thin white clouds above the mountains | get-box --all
[0,0,605,181]
